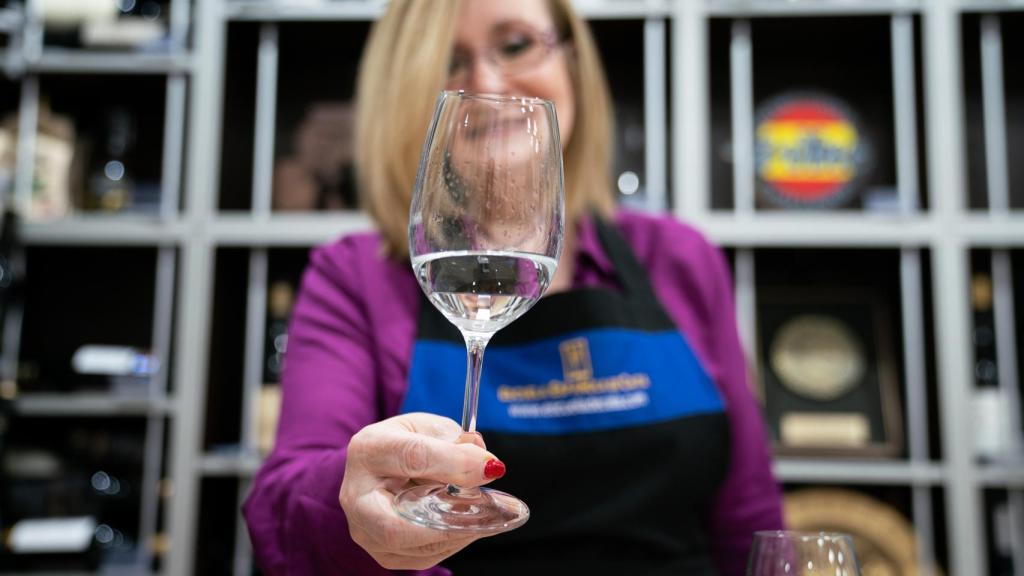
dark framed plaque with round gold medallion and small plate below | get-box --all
[757,287,903,457]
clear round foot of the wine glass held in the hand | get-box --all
[394,484,529,534]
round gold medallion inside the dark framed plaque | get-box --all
[770,315,866,402]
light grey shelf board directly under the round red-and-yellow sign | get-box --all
[688,212,936,248]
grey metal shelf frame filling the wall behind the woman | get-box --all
[0,0,1024,576]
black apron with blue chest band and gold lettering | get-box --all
[400,219,729,576]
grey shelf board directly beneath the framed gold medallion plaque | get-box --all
[775,458,944,486]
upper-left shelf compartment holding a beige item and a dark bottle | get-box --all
[19,75,167,221]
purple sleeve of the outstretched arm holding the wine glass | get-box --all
[243,241,448,575]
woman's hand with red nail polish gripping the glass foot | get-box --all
[338,413,505,570]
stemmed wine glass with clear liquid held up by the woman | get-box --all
[394,91,565,534]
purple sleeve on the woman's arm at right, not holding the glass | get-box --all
[622,217,782,576]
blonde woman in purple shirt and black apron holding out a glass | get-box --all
[245,0,781,575]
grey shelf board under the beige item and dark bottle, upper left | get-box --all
[20,214,185,246]
